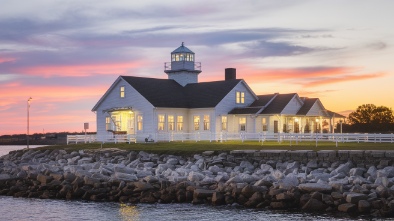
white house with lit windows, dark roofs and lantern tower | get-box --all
[92,43,344,140]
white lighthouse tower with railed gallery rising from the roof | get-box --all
[164,42,201,86]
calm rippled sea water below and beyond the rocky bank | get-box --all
[0,146,388,221]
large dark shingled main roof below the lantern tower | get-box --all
[121,76,242,108]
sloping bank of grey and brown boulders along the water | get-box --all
[0,148,394,217]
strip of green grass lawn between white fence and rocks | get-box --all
[36,141,394,155]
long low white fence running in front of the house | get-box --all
[67,132,394,145]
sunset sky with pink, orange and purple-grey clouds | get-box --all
[0,0,394,135]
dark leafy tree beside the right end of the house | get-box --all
[348,104,394,124]
